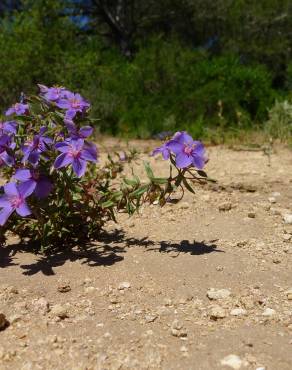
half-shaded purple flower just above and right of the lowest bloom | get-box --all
[13,169,53,198]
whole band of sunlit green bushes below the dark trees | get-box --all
[0,8,277,138]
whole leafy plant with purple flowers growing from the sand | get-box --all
[0,85,211,252]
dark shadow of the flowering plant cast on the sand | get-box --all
[0,231,223,276]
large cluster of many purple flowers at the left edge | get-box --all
[0,85,98,226]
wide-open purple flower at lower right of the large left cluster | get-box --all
[54,139,97,177]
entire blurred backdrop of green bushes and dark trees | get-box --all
[0,0,292,138]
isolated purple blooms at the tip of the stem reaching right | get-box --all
[152,131,207,170]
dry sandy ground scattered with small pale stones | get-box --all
[0,144,292,370]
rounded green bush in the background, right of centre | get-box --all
[95,40,277,138]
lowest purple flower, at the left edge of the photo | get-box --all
[0,182,33,226]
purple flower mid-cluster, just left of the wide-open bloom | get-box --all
[22,126,53,165]
